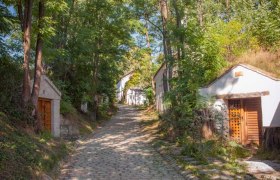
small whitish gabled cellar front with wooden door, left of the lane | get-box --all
[31,75,61,137]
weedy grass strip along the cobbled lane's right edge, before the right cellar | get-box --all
[142,107,251,179]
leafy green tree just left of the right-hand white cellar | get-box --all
[161,16,225,136]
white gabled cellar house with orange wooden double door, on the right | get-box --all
[200,64,280,144]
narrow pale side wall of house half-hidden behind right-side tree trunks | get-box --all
[154,65,166,112]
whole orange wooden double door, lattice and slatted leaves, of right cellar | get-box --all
[228,98,262,145]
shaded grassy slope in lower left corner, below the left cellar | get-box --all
[0,114,71,179]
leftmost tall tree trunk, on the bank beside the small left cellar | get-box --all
[22,0,33,107]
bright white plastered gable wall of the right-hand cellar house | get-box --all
[200,65,280,127]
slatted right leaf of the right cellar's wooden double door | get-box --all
[244,98,262,145]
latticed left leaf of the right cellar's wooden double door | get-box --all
[228,100,242,143]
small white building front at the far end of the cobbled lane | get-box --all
[126,89,147,105]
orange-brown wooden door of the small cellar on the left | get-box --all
[38,98,51,131]
